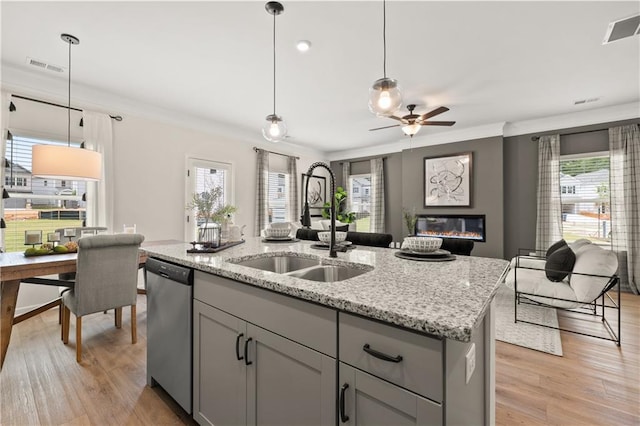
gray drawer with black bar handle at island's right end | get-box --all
[338,312,444,402]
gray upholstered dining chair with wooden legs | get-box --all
[62,234,144,362]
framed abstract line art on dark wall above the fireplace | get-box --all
[424,152,473,207]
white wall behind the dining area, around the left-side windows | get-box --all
[2,92,325,313]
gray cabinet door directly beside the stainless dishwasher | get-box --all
[193,300,247,426]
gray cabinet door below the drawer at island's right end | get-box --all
[338,363,442,426]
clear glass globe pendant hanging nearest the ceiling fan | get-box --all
[369,0,402,117]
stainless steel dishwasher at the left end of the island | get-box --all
[145,258,193,414]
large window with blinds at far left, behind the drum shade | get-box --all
[3,135,87,252]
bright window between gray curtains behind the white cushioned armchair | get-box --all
[560,153,611,246]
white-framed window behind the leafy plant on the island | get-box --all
[185,158,233,241]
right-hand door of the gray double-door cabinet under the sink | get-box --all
[247,324,336,426]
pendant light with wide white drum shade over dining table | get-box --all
[31,34,102,181]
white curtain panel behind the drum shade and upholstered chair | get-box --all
[82,111,115,232]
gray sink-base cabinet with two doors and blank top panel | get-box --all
[193,274,337,426]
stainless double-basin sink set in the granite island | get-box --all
[230,255,373,282]
